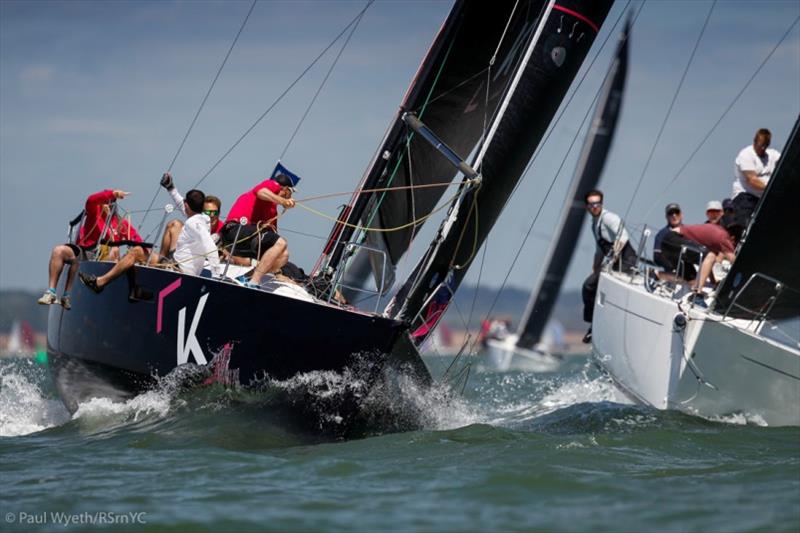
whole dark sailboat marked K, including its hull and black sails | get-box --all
[48,0,611,426]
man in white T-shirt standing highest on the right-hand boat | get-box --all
[732,128,781,228]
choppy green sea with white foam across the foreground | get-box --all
[0,352,800,532]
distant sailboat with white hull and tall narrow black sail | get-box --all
[488,22,630,371]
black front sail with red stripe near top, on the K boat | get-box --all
[387,0,612,344]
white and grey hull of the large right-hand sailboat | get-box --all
[592,272,800,426]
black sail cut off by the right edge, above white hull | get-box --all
[716,116,800,319]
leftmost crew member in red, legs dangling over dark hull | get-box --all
[37,189,139,310]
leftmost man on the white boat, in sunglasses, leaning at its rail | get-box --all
[582,189,636,343]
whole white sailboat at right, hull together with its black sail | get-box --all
[592,118,800,426]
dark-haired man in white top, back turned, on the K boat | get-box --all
[173,189,221,276]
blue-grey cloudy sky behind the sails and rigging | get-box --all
[0,0,800,300]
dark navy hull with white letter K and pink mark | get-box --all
[47,262,430,411]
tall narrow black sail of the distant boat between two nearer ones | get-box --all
[517,18,630,349]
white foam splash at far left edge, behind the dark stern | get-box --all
[0,359,69,437]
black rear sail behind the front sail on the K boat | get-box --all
[323,0,552,290]
